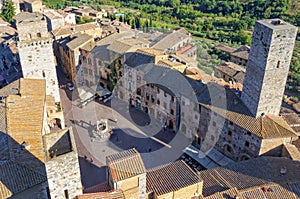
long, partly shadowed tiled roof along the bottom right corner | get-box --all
[199,157,300,196]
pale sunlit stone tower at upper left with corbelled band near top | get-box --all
[16,12,60,102]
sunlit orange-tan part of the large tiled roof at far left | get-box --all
[6,79,46,162]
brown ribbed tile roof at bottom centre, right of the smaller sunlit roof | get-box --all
[147,160,201,196]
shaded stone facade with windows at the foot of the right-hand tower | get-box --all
[199,107,262,161]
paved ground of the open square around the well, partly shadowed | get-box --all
[58,69,191,187]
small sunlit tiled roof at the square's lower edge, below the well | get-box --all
[106,149,146,182]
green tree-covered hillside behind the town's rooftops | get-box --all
[44,0,300,85]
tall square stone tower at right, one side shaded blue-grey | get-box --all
[241,19,297,117]
